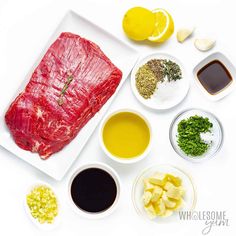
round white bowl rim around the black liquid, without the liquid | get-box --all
[68,162,121,219]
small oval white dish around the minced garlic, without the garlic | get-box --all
[23,181,61,230]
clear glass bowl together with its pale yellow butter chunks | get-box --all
[132,165,196,223]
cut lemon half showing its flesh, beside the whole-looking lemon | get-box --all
[148,8,174,43]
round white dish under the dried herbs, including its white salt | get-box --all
[131,53,189,110]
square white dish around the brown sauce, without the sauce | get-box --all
[193,52,236,101]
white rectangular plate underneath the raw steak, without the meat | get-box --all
[0,11,138,180]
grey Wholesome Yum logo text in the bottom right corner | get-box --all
[179,211,229,235]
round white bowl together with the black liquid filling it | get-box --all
[69,164,120,218]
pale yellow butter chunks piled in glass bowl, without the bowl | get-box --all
[143,172,185,218]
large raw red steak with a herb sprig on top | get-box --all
[5,32,122,159]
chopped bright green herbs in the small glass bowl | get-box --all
[177,115,213,157]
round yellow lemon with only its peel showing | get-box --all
[123,7,155,41]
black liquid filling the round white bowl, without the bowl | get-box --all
[71,168,117,213]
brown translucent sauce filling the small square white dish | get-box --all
[197,60,232,95]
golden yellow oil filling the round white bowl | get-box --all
[103,112,150,158]
